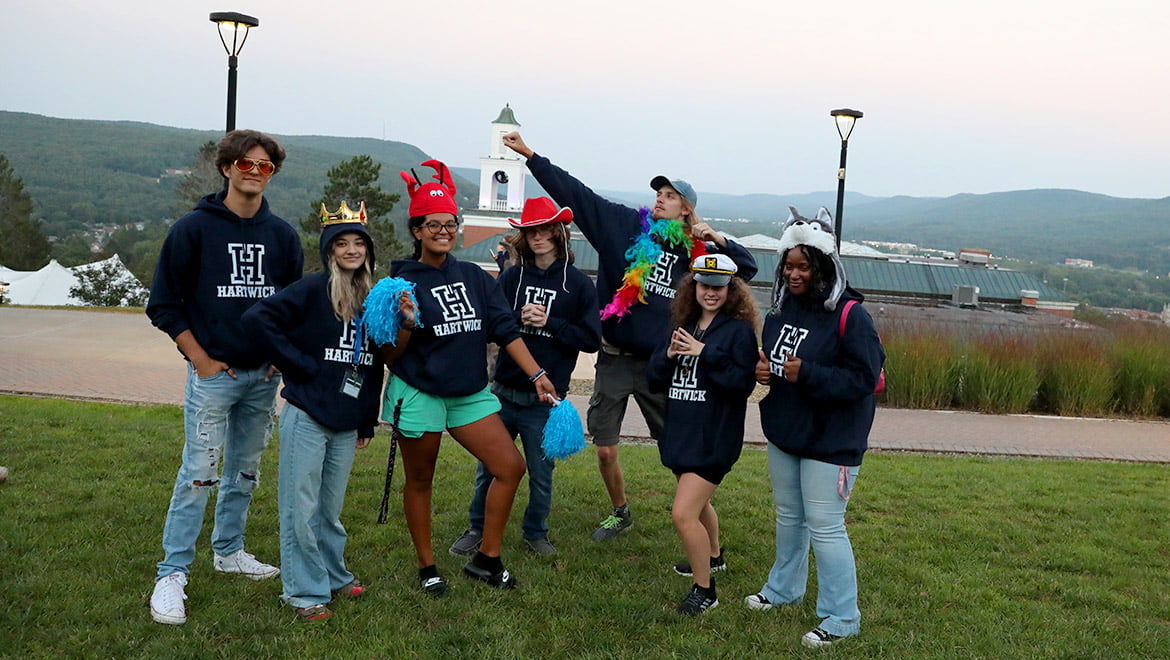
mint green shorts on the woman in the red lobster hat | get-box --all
[381,374,500,438]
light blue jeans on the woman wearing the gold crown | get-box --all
[277,403,358,607]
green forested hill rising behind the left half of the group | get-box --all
[0,111,479,238]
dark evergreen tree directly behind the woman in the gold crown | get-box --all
[301,154,407,279]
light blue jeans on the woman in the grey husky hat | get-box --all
[763,444,861,637]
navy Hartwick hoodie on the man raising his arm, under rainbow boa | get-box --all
[528,153,756,357]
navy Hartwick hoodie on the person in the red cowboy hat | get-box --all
[495,259,601,394]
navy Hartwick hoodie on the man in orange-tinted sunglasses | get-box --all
[146,192,304,369]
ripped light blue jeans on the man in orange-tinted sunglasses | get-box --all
[158,363,281,578]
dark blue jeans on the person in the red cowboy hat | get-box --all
[468,386,555,541]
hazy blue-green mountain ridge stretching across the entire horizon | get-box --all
[0,111,1170,275]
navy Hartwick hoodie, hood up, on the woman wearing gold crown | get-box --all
[243,222,385,438]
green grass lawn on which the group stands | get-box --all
[0,397,1170,659]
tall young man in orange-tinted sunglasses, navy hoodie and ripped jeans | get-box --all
[146,130,304,625]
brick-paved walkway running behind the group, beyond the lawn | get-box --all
[0,307,1170,463]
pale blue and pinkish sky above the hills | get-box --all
[0,0,1170,198]
